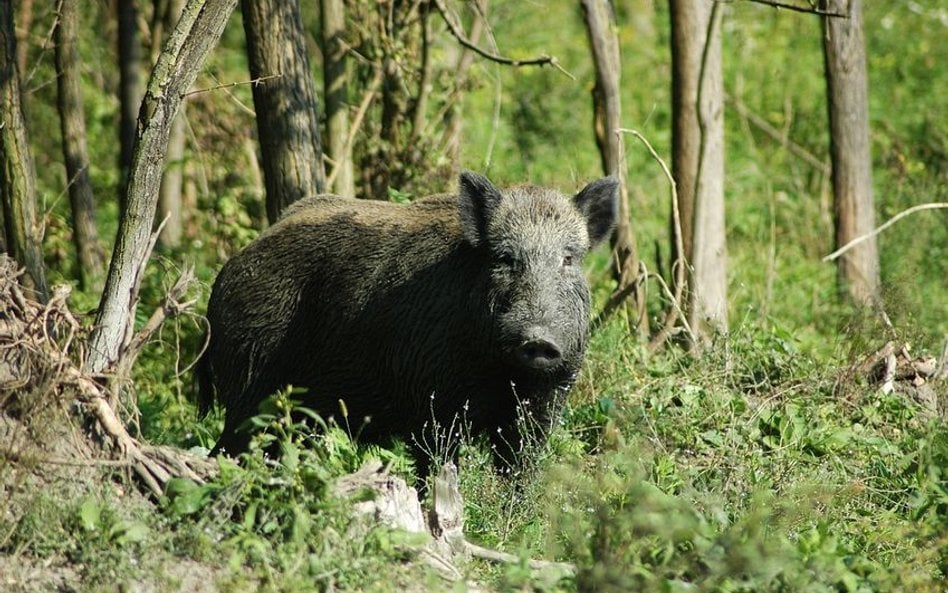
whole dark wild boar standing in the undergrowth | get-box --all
[198,173,618,466]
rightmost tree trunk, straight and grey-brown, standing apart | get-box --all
[822,0,880,305]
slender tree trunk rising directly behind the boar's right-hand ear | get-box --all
[582,0,648,336]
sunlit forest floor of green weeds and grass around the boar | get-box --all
[0,260,948,593]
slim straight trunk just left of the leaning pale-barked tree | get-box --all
[55,0,105,292]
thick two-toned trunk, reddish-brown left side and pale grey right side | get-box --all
[671,0,727,346]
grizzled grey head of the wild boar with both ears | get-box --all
[459,173,619,377]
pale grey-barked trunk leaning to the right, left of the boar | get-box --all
[84,0,237,374]
